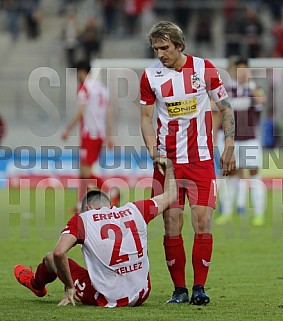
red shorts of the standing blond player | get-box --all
[151,160,216,209]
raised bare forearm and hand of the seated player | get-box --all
[153,158,177,213]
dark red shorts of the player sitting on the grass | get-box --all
[68,259,151,307]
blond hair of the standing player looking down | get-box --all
[147,21,185,51]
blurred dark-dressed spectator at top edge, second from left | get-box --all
[24,0,41,39]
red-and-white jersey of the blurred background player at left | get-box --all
[78,77,109,138]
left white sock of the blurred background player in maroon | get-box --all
[217,176,238,216]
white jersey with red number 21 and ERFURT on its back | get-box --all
[62,200,158,307]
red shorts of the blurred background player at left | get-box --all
[80,136,103,166]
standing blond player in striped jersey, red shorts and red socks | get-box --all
[140,21,235,305]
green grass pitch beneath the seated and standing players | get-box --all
[0,189,283,321]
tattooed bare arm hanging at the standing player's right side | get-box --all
[216,99,236,176]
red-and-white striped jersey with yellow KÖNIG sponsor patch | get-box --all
[140,56,228,164]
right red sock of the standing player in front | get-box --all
[192,233,213,286]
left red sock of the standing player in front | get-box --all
[163,235,186,288]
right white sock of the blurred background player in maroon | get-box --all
[250,175,267,216]
